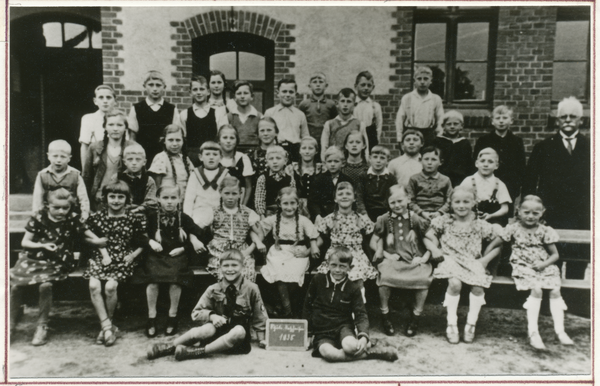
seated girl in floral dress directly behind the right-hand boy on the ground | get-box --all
[316,181,378,297]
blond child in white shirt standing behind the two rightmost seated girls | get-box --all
[460,147,512,226]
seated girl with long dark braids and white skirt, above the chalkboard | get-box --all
[261,187,319,318]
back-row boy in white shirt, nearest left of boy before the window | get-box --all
[354,71,383,151]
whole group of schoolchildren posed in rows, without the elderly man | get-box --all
[10,67,573,361]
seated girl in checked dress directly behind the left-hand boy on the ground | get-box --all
[206,176,266,281]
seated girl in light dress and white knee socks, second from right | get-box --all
[426,187,500,344]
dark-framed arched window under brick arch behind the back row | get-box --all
[192,32,275,112]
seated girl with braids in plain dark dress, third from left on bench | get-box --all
[132,185,206,338]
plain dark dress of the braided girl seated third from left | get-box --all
[132,210,203,287]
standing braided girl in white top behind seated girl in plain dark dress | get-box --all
[148,125,194,197]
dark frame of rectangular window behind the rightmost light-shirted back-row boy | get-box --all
[411,7,498,109]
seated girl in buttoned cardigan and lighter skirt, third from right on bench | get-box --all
[371,185,433,336]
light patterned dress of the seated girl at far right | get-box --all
[501,222,561,291]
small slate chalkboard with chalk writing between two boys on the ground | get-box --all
[267,319,308,351]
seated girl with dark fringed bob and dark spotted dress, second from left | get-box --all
[84,181,148,347]
